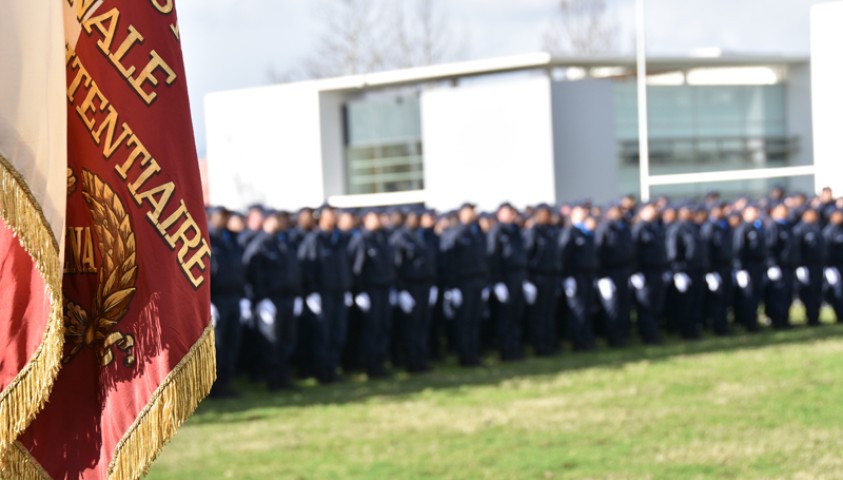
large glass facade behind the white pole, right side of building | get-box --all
[614,81,799,198]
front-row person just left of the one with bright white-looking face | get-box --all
[524,204,562,356]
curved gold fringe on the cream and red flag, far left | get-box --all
[0,155,64,462]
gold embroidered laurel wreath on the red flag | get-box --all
[62,170,138,367]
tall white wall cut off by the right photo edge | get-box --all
[811,2,843,195]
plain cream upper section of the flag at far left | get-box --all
[0,0,67,243]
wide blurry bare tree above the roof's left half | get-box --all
[276,0,461,81]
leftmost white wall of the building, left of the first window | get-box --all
[205,83,326,209]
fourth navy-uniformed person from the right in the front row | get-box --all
[732,205,768,332]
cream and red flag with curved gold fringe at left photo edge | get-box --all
[0,1,67,462]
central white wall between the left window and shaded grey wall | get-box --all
[421,76,556,210]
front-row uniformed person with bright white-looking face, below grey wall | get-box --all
[559,206,597,351]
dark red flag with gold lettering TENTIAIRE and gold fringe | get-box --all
[9,0,215,479]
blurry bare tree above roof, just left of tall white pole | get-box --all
[543,0,620,55]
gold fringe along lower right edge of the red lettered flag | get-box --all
[108,325,216,480]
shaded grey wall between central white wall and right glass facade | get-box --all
[552,80,621,203]
